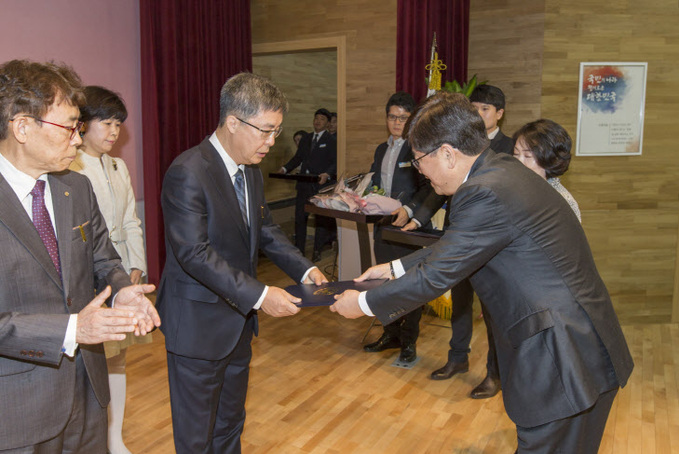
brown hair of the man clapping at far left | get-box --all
[0,60,85,140]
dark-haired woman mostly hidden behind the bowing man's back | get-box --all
[514,119,582,222]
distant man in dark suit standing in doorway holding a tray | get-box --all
[280,109,337,261]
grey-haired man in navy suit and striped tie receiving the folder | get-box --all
[158,73,327,454]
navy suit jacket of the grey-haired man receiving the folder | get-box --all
[157,139,313,360]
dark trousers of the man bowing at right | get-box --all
[516,388,618,454]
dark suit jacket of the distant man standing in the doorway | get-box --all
[283,131,337,193]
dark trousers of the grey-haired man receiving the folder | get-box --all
[167,317,255,454]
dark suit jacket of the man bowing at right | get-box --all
[366,150,633,427]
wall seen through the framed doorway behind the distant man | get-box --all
[252,50,337,202]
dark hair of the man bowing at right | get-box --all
[406,92,490,156]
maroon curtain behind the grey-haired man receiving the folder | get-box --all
[139,0,252,284]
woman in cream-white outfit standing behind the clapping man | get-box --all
[70,86,151,454]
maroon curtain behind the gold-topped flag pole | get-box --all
[396,0,469,102]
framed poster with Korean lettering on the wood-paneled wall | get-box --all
[575,63,648,156]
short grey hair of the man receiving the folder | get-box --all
[219,72,288,126]
